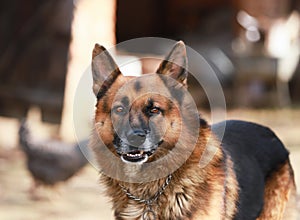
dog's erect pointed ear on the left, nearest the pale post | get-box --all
[92,44,121,98]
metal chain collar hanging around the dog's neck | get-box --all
[119,174,172,220]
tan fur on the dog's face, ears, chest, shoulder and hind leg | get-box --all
[90,42,295,220]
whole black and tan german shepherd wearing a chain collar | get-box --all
[90,41,296,220]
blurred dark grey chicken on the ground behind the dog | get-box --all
[19,121,88,198]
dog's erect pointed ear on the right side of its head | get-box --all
[156,41,188,86]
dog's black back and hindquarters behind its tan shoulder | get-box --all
[212,120,294,219]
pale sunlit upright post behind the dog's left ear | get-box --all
[60,0,116,141]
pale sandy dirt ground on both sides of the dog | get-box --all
[0,109,300,220]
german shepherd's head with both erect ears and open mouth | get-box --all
[92,42,198,167]
